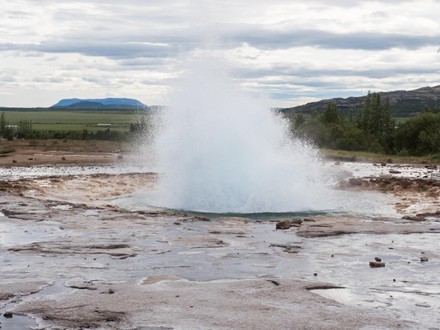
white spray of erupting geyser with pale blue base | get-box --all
[155,58,326,213]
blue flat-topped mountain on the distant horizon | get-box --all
[51,98,147,109]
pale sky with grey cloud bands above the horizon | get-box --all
[0,0,440,107]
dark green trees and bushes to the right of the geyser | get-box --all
[289,93,440,155]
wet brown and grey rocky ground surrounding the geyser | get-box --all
[0,163,440,329]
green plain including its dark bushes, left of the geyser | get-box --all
[0,109,149,140]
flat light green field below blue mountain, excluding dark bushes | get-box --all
[4,110,147,132]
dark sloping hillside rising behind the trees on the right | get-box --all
[281,85,440,117]
